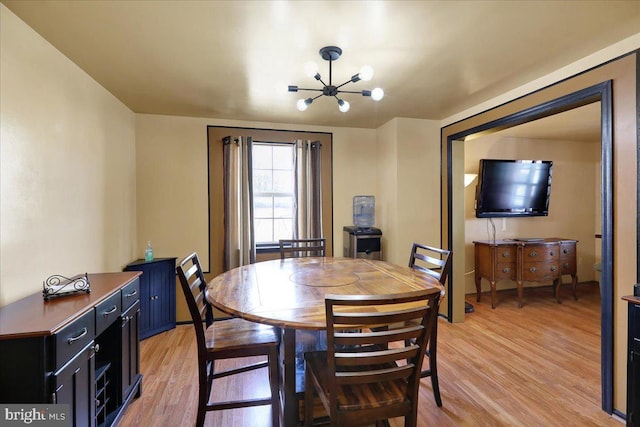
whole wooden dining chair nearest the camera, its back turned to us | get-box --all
[304,289,440,427]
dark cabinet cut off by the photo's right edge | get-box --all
[623,296,640,427]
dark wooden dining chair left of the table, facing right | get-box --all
[176,253,280,427]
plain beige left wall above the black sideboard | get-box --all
[0,4,136,306]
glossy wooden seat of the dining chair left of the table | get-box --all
[205,318,279,352]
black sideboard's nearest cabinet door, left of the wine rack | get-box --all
[52,341,96,427]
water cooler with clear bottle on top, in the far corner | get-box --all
[342,196,382,260]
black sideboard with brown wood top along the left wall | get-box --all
[0,272,142,427]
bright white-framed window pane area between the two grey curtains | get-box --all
[252,141,295,245]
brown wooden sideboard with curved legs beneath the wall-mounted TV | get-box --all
[473,237,578,308]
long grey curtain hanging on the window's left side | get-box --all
[222,136,256,271]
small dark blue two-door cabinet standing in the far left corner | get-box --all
[124,258,176,339]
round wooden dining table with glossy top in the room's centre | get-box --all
[207,257,443,427]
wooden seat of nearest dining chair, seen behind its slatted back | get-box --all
[305,351,407,411]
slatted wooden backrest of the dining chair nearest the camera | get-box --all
[325,290,440,410]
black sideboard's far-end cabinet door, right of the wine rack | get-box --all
[120,302,140,403]
